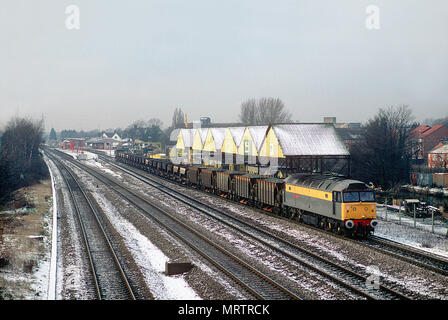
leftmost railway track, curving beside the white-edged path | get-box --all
[47,153,135,300]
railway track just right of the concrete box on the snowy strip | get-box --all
[47,150,302,300]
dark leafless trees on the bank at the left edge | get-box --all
[0,118,49,202]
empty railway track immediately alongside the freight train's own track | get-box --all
[93,151,409,299]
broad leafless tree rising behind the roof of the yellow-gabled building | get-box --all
[239,98,291,125]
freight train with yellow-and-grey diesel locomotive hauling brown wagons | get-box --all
[115,150,378,237]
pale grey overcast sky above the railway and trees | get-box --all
[0,0,448,131]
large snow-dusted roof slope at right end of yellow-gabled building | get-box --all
[272,123,350,156]
